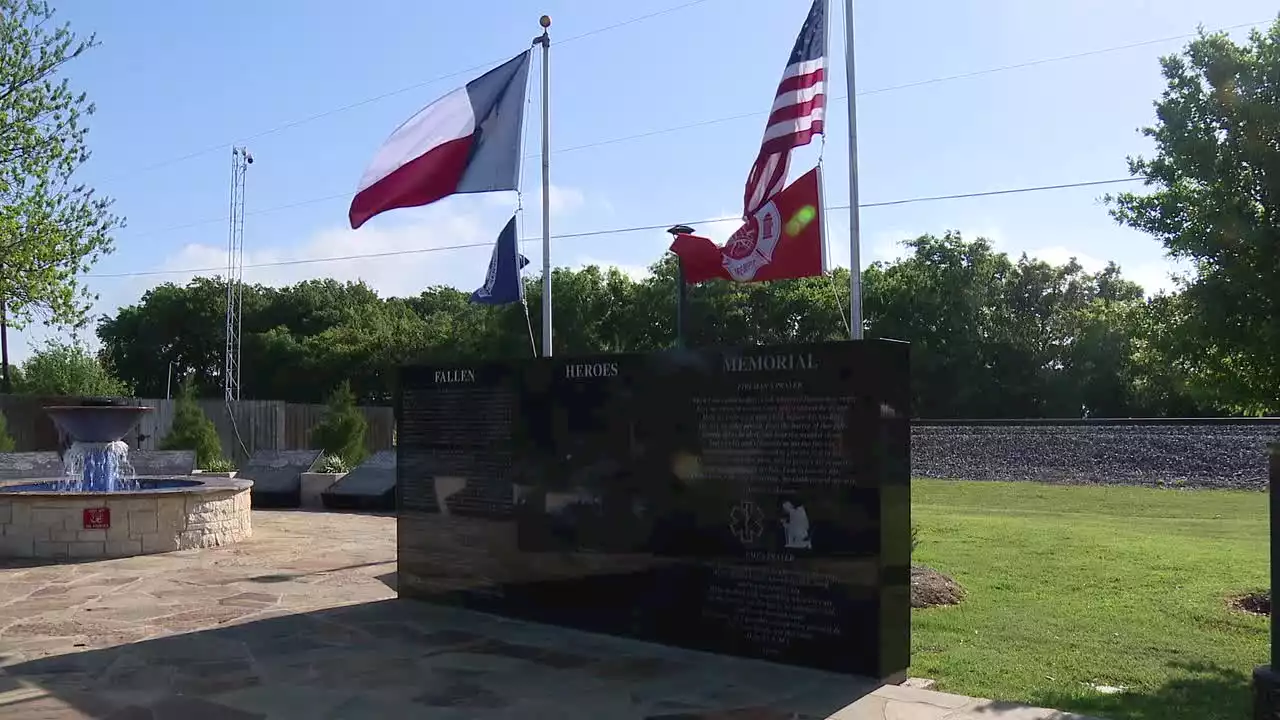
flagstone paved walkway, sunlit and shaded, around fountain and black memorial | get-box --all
[0,511,1100,720]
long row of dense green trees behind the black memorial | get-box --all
[85,232,1275,418]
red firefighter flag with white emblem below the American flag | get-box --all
[671,168,826,284]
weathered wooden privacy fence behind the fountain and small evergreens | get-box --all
[0,395,396,461]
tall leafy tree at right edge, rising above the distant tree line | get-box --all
[1110,20,1280,414]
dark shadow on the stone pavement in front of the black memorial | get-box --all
[0,594,876,720]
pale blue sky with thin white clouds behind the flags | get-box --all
[13,0,1275,361]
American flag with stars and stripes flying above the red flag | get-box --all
[742,0,827,217]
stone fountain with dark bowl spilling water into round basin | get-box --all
[0,400,253,559]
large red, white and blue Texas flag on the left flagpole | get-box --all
[348,50,531,228]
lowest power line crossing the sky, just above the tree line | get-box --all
[84,177,1146,278]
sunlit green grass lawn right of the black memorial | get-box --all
[911,480,1267,720]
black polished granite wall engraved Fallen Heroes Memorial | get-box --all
[396,341,911,680]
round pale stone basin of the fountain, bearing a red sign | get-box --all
[0,477,253,560]
